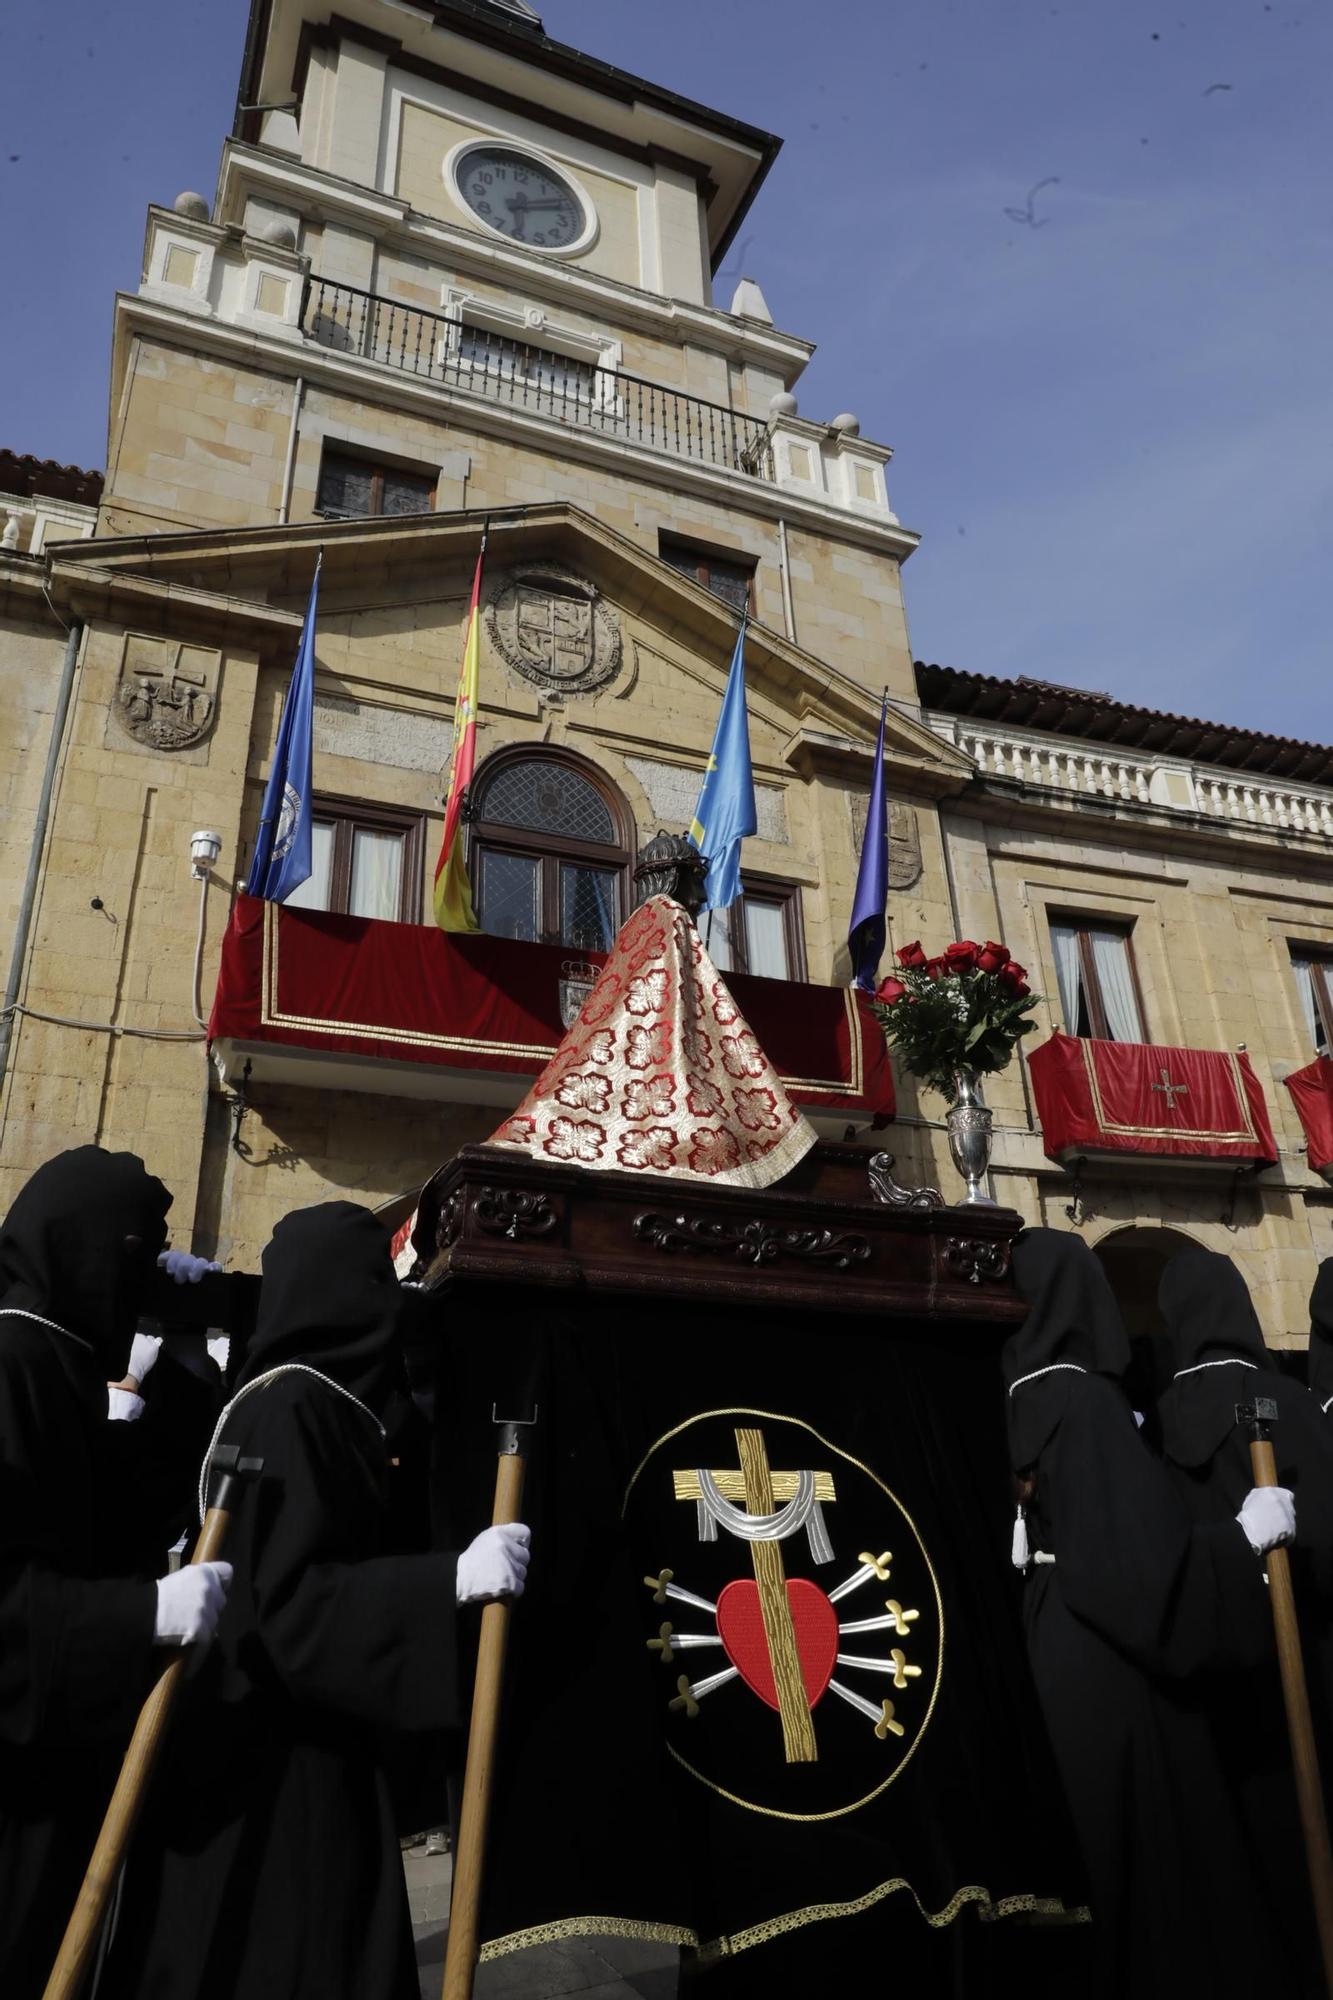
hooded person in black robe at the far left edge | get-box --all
[0,1146,170,2000]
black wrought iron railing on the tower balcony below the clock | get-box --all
[300,278,773,480]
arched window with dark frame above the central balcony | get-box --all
[472,744,632,952]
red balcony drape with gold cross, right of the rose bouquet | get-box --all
[1027,1034,1277,1166]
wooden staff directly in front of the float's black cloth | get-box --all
[442,1406,536,2000]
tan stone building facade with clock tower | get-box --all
[0,0,1333,1340]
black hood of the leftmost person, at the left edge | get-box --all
[0,1146,172,1382]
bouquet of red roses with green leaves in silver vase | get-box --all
[871,938,1037,1104]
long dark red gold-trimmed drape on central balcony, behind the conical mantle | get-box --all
[208,896,895,1124]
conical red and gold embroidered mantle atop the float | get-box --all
[490,896,815,1188]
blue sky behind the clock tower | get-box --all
[0,0,1333,742]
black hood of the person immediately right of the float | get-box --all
[1003,1230,1129,1472]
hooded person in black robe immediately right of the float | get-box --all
[1005,1230,1269,2000]
